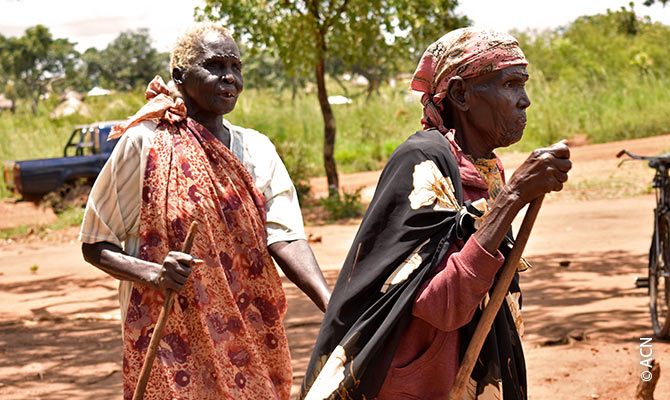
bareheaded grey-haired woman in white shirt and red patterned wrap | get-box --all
[80,23,329,400]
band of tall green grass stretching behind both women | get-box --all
[0,71,670,197]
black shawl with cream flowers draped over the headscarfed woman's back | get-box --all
[300,130,464,400]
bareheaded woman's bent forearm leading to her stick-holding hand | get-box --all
[81,242,161,289]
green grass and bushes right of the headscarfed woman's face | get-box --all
[515,8,670,150]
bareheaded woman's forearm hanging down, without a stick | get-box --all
[268,240,330,311]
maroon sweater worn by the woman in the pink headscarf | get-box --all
[379,134,504,400]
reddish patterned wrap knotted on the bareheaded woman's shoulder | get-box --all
[118,76,292,400]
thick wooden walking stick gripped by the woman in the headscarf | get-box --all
[449,196,544,400]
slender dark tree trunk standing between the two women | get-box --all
[315,53,340,193]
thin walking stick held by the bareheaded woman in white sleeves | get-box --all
[133,221,198,400]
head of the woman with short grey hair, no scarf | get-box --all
[180,32,244,116]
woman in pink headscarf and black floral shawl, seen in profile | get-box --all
[302,28,571,399]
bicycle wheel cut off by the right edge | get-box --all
[649,214,670,339]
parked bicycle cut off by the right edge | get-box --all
[617,149,670,339]
